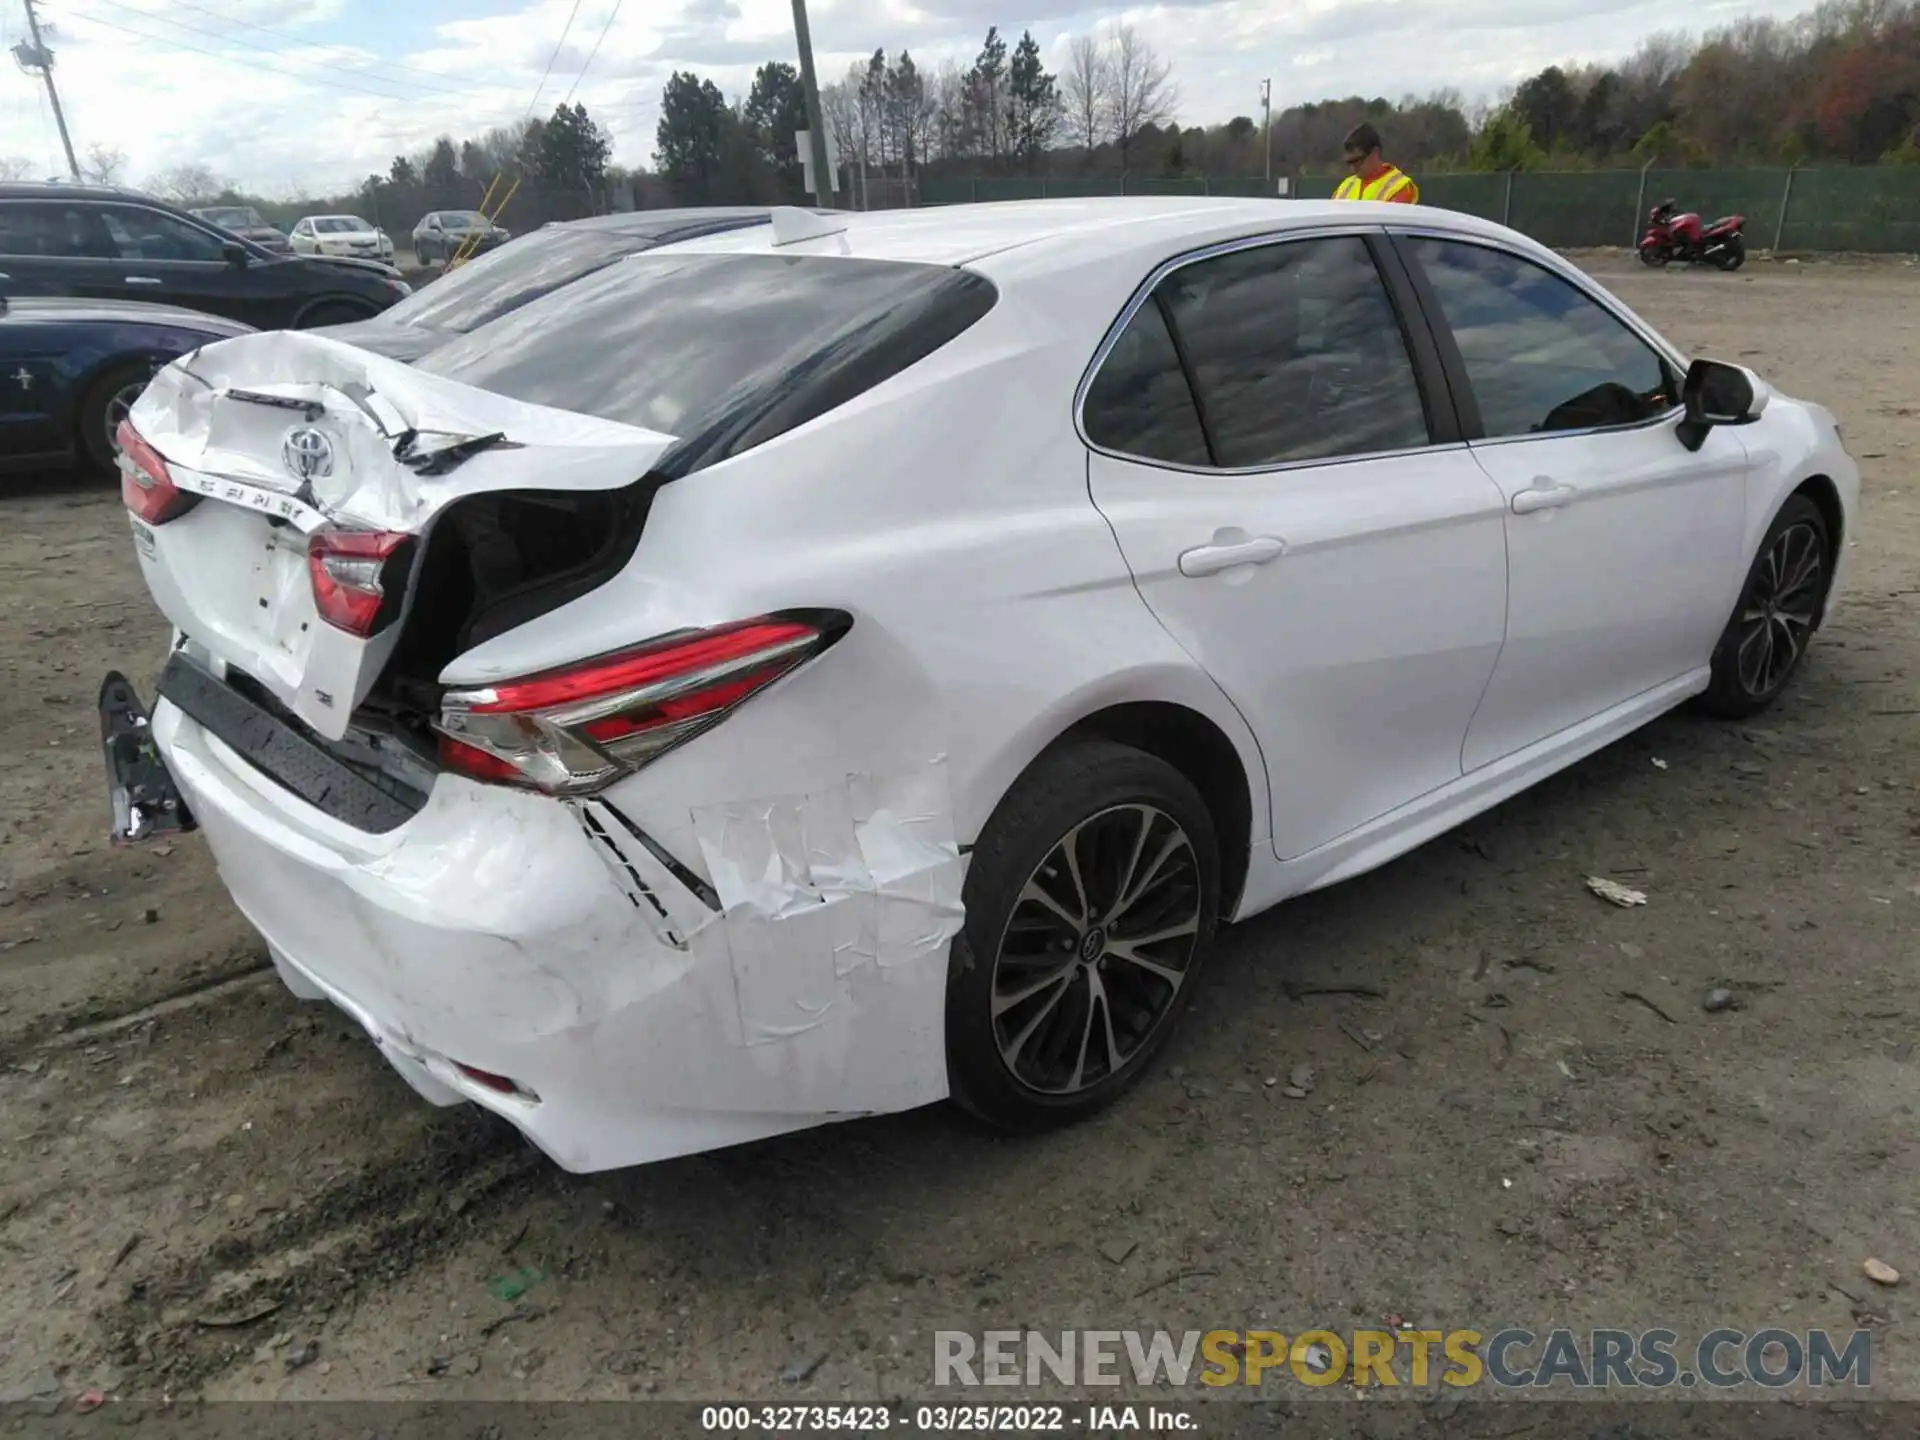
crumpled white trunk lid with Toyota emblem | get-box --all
[131,332,674,739]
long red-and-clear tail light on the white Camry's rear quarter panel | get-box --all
[438,614,851,795]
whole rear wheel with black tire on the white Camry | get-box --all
[947,739,1219,1131]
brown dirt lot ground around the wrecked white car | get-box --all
[0,261,1920,1428]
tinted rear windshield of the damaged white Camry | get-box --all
[412,253,995,474]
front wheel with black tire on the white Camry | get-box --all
[1699,495,1834,720]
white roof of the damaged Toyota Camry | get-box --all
[645,196,1536,278]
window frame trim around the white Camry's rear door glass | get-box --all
[1073,221,1467,476]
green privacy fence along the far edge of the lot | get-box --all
[920,165,1920,253]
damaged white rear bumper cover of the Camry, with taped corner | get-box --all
[154,660,964,1171]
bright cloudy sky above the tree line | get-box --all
[0,0,1809,198]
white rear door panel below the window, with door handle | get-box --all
[1091,445,1507,858]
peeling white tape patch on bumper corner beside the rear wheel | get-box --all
[693,756,964,1046]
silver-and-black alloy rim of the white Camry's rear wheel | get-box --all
[993,804,1202,1096]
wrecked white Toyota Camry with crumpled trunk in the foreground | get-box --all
[108,200,1859,1169]
